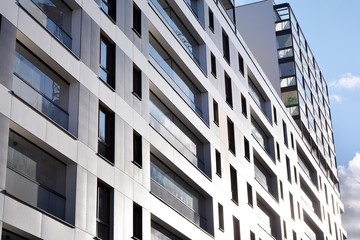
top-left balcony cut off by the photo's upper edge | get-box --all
[17,0,72,49]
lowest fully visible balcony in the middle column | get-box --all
[151,155,210,231]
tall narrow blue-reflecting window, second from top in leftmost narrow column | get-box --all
[99,35,115,88]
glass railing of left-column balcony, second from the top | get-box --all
[13,74,69,129]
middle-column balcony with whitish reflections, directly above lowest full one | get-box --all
[150,93,211,176]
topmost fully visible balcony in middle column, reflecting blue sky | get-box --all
[149,34,204,119]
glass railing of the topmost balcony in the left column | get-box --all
[17,0,72,49]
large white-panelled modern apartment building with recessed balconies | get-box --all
[0,0,346,240]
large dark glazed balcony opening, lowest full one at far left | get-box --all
[4,131,68,220]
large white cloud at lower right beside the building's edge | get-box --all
[339,153,360,240]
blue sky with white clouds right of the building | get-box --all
[236,0,360,237]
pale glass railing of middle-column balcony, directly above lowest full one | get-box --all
[150,94,205,172]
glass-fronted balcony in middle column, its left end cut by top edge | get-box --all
[150,0,199,63]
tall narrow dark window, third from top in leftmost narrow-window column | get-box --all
[98,104,115,163]
